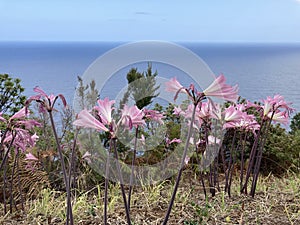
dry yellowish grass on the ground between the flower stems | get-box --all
[0,171,300,225]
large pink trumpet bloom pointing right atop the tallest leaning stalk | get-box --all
[203,75,238,102]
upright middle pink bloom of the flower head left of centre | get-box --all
[94,97,115,125]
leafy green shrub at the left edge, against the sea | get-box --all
[0,74,26,115]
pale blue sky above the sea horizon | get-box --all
[0,0,300,42]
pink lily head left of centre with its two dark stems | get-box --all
[74,98,145,224]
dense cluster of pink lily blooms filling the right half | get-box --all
[166,75,292,132]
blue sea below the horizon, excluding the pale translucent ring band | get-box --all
[0,42,300,111]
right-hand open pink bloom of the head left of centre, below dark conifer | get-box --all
[121,105,146,129]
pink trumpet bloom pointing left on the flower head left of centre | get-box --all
[73,109,109,131]
